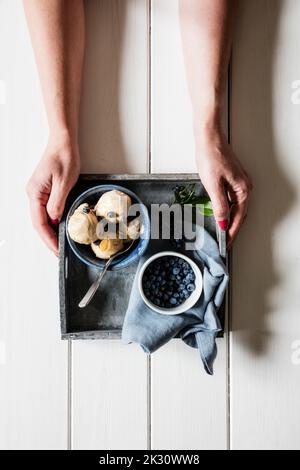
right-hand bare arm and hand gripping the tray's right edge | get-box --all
[179,0,251,245]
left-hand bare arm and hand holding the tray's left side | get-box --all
[24,0,84,254]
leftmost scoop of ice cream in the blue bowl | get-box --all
[68,203,98,245]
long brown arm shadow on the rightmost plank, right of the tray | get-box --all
[231,0,295,354]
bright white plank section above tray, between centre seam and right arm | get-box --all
[151,0,196,173]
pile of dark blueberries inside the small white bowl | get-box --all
[142,256,195,308]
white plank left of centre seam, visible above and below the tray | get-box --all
[72,0,148,449]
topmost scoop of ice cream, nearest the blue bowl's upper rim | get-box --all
[95,189,131,223]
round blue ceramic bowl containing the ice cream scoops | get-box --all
[66,184,150,271]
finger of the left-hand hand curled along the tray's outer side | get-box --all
[30,199,58,256]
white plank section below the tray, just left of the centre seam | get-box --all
[73,340,147,450]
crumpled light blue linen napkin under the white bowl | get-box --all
[122,227,229,375]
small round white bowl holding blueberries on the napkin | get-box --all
[138,251,203,315]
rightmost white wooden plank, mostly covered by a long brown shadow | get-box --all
[231,0,300,450]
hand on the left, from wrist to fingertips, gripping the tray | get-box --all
[26,132,80,256]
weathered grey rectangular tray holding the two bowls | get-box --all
[59,174,228,339]
